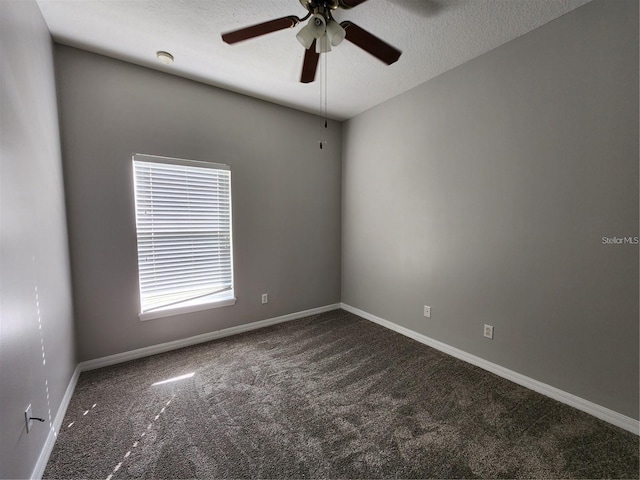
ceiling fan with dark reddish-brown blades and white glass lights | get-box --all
[222,0,402,83]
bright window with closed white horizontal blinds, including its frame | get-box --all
[133,155,235,320]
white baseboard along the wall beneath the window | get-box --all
[78,303,340,372]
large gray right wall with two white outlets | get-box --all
[342,0,639,419]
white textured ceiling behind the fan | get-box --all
[37,0,590,120]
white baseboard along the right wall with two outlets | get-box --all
[341,303,640,435]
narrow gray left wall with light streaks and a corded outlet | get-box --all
[0,0,76,478]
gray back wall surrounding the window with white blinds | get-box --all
[56,46,341,361]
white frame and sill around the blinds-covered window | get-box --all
[131,153,236,321]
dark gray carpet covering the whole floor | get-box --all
[44,310,639,480]
